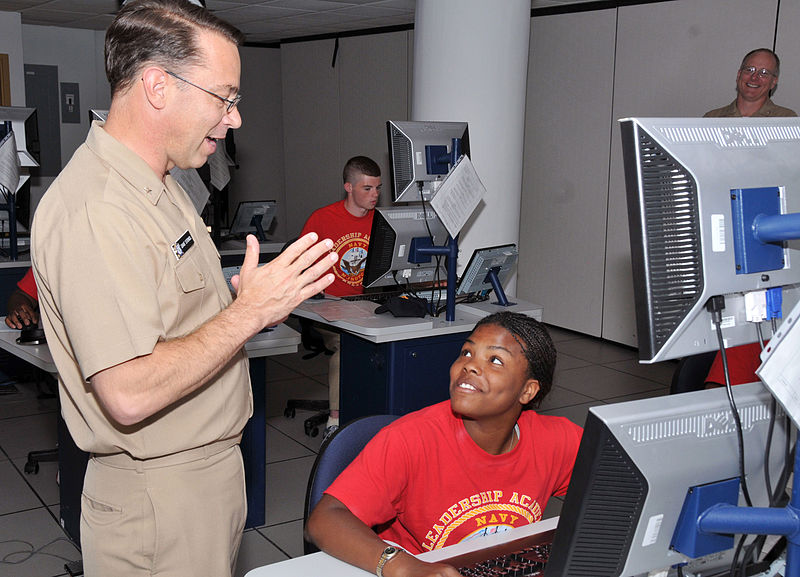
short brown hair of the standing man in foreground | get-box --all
[105,0,244,96]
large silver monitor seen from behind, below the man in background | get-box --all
[620,118,800,362]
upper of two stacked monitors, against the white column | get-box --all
[386,120,469,202]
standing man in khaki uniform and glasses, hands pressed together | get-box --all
[32,0,336,577]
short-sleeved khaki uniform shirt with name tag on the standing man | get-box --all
[32,123,253,459]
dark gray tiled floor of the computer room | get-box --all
[0,328,674,577]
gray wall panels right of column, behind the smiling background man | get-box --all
[518,0,780,345]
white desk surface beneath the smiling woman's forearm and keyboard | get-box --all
[245,517,558,577]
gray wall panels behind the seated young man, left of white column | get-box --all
[281,32,411,237]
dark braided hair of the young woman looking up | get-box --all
[474,312,556,409]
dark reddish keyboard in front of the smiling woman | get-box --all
[434,529,555,577]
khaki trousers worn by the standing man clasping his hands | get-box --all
[81,441,247,577]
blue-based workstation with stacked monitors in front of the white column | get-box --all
[293,121,542,424]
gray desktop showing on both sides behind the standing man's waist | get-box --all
[0,317,300,374]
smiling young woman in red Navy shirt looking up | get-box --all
[306,312,583,577]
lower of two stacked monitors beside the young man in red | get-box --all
[363,204,448,288]
